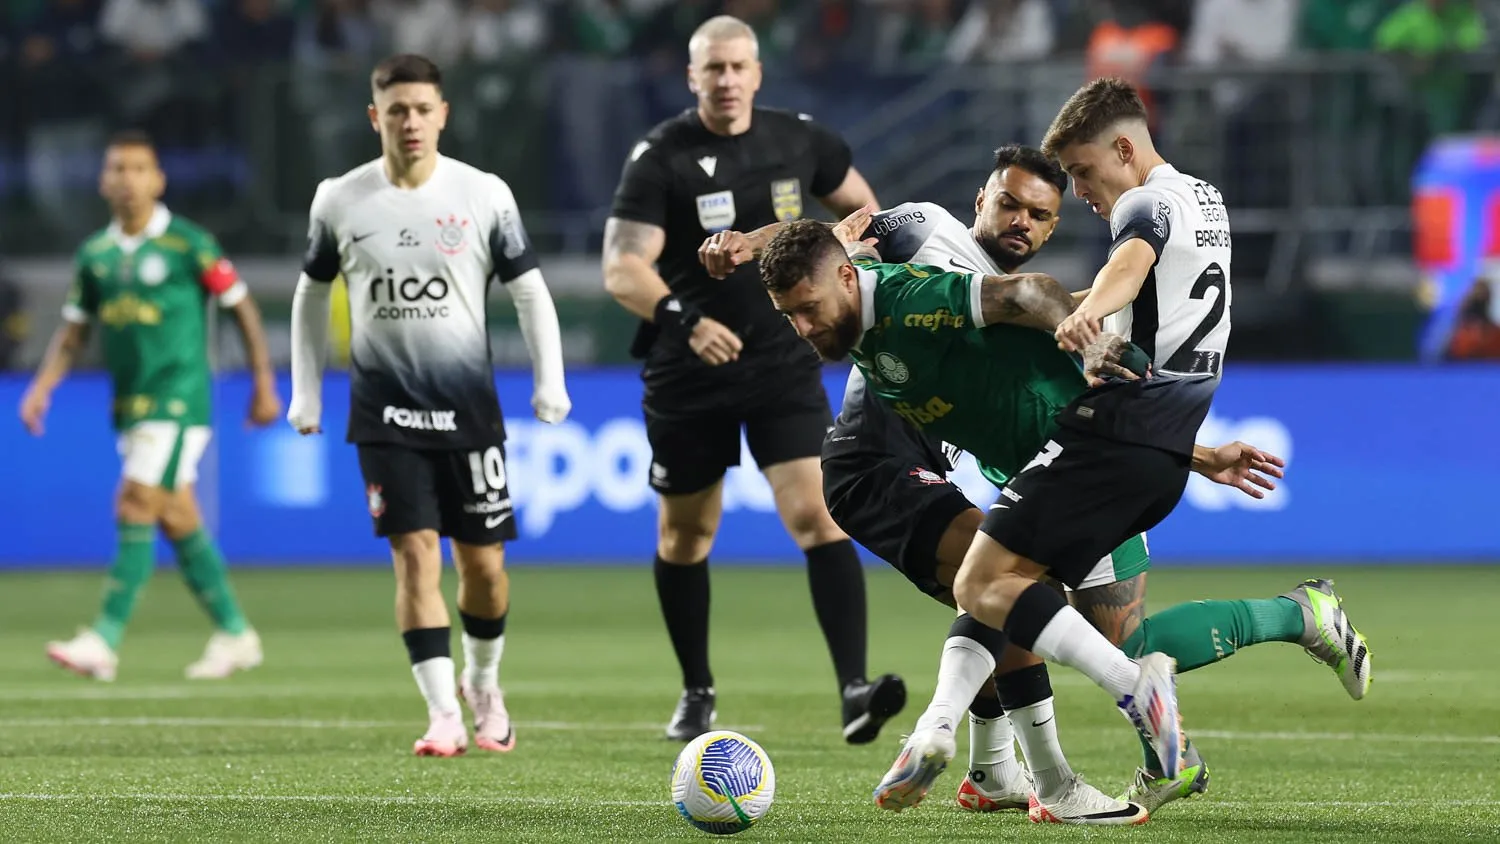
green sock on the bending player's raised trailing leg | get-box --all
[1121,598,1302,771]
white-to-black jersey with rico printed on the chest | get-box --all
[303,157,537,448]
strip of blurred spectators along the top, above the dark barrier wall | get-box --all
[6,0,1500,70]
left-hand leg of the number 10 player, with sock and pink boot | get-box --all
[390,531,468,757]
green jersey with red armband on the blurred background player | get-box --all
[63,205,248,429]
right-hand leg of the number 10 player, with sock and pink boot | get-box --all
[453,541,516,753]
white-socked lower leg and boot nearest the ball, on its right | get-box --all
[875,613,1005,811]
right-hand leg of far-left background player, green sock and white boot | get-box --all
[161,484,264,679]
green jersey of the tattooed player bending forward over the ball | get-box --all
[851,261,1088,483]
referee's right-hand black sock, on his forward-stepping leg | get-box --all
[804,540,867,688]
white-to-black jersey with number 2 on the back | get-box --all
[1062,165,1233,454]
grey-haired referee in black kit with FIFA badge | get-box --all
[603,16,906,744]
